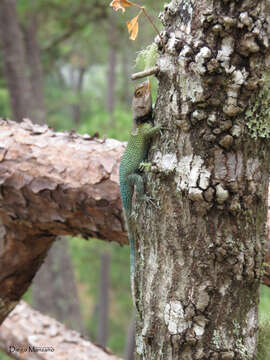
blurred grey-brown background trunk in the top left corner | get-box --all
[0,0,34,121]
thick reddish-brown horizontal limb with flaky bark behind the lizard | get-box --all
[0,120,127,322]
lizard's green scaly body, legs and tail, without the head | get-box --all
[120,122,161,301]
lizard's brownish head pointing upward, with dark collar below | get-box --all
[132,80,152,122]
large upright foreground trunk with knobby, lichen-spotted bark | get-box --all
[134,0,270,360]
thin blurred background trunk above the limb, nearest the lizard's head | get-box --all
[106,19,117,126]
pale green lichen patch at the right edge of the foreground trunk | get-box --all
[246,74,270,139]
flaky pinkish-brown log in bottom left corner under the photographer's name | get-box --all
[0,301,120,360]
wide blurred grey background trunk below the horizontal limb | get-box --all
[32,236,84,333]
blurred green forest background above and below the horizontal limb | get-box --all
[0,0,270,360]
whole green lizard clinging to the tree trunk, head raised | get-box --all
[120,81,161,302]
